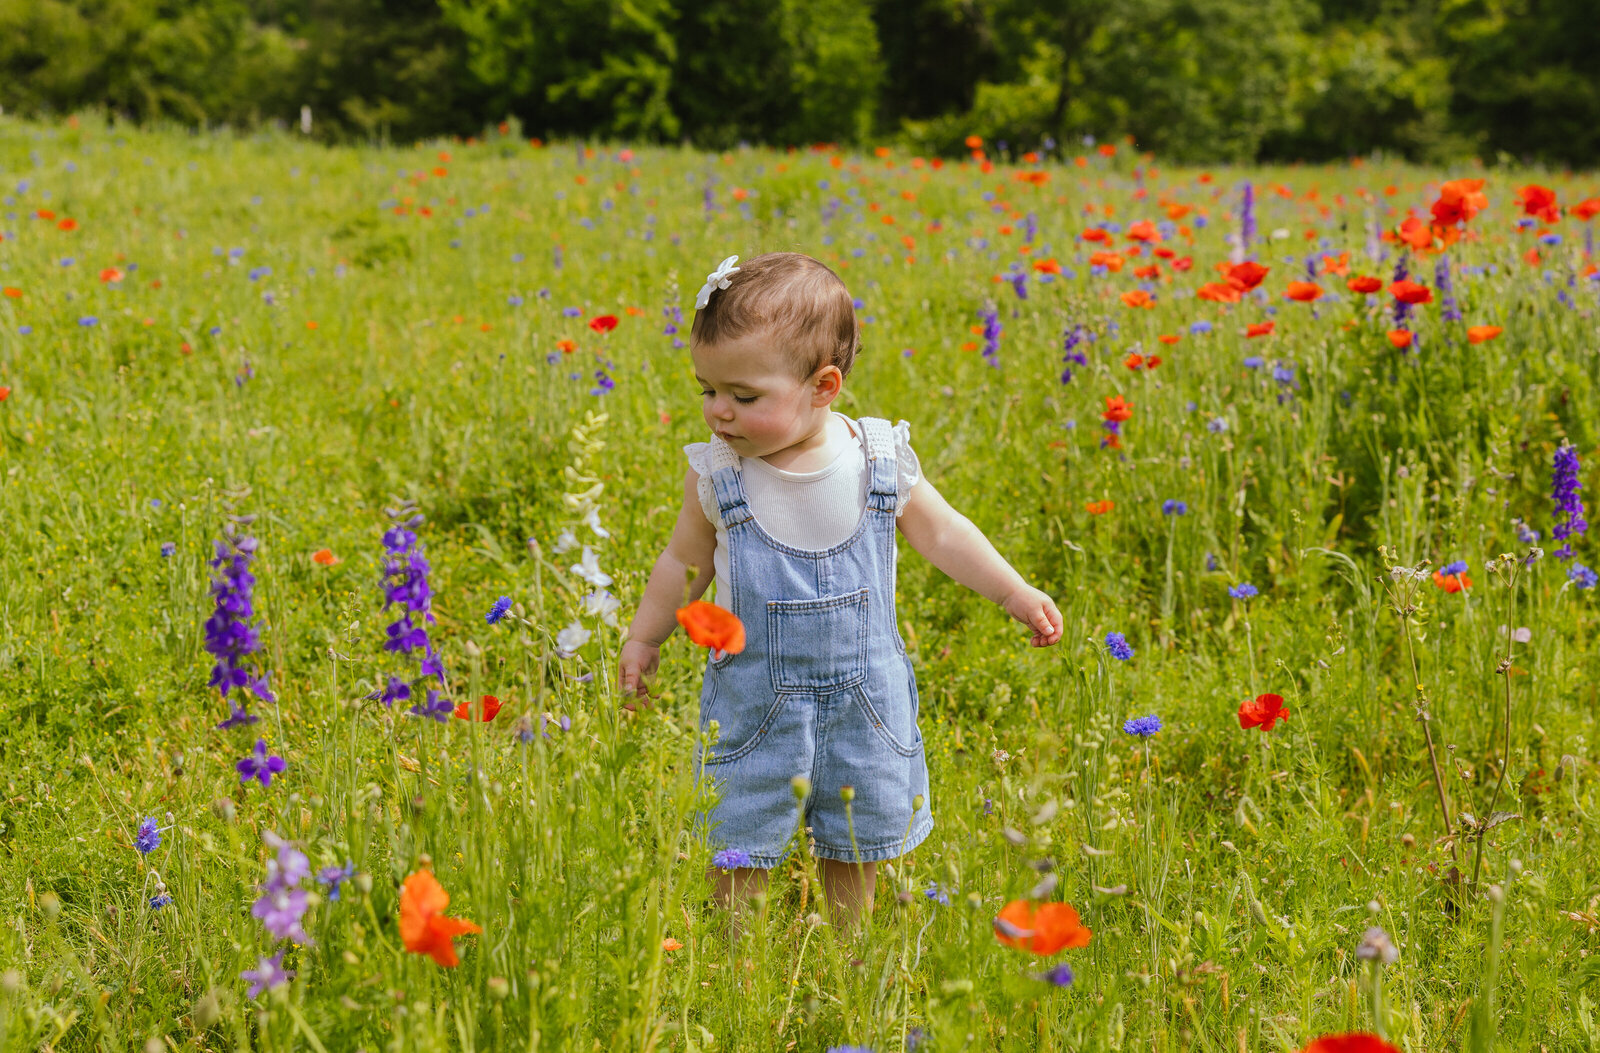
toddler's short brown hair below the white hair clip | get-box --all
[690,253,861,379]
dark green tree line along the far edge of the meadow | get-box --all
[0,0,1600,165]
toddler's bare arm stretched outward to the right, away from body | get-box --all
[898,478,1062,647]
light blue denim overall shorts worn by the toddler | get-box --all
[696,418,933,867]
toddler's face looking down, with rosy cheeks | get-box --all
[690,333,834,458]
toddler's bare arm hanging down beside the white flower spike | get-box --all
[618,469,717,696]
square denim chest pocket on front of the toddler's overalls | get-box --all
[766,587,867,693]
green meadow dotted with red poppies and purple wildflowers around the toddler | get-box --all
[0,118,1600,1053]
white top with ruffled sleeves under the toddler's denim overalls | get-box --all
[683,413,922,599]
